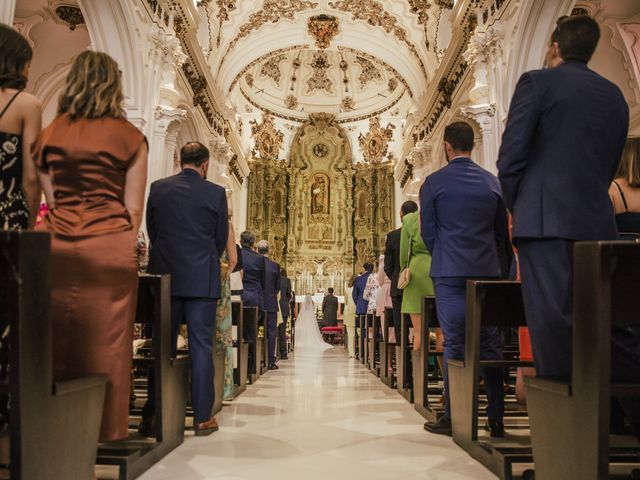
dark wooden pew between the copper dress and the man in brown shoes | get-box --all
[97,275,191,480]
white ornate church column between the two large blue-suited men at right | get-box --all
[460,14,504,173]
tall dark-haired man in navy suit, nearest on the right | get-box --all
[498,16,640,435]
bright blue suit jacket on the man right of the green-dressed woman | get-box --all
[420,158,509,278]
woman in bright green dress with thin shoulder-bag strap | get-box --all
[400,212,434,350]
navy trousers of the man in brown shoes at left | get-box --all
[171,297,218,423]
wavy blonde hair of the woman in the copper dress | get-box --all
[58,51,125,120]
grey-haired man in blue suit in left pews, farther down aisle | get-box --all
[258,240,280,370]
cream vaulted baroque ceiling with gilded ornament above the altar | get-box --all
[200,0,453,160]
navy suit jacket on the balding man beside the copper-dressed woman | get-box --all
[147,169,229,298]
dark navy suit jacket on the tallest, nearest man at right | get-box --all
[498,61,629,240]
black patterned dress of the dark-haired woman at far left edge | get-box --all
[0,92,29,230]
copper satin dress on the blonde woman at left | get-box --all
[34,115,145,441]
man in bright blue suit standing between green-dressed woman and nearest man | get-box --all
[420,122,508,437]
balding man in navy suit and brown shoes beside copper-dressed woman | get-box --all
[147,142,229,435]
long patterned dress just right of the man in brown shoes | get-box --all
[216,251,234,400]
